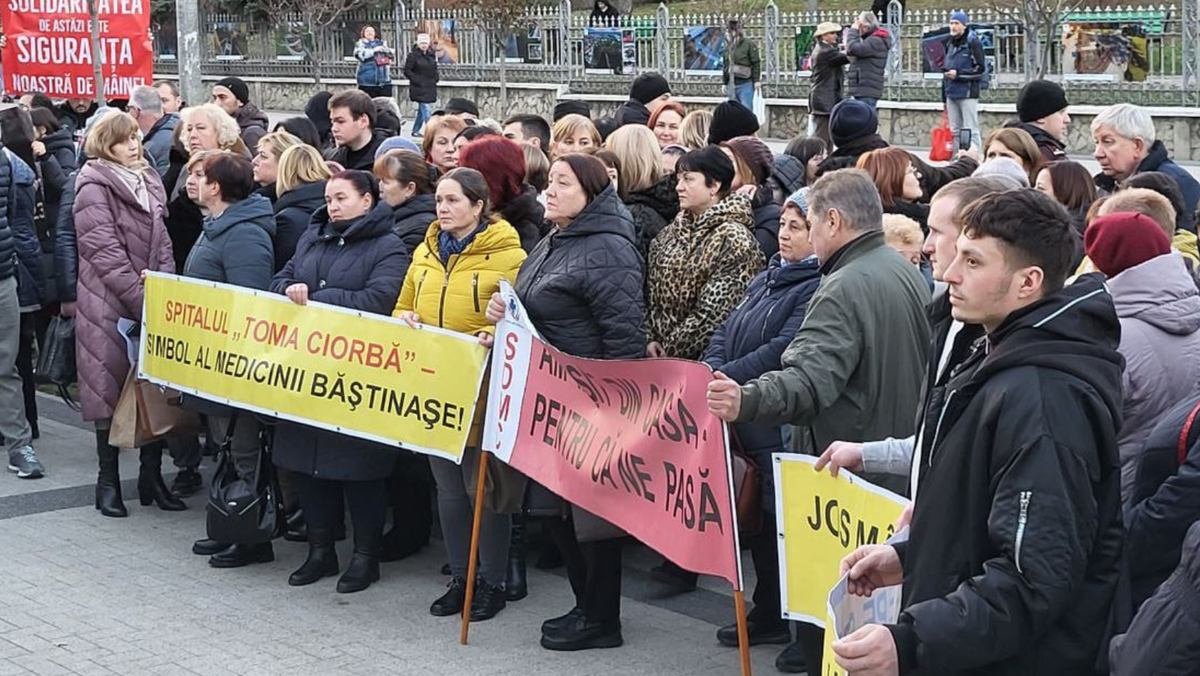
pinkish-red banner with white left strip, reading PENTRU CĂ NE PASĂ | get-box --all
[484,321,742,590]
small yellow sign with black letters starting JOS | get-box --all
[774,454,907,627]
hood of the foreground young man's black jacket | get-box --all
[965,274,1124,420]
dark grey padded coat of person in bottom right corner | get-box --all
[1109,518,1200,676]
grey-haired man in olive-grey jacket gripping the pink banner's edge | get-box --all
[708,169,931,674]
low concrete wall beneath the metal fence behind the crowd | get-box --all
[164,76,1200,162]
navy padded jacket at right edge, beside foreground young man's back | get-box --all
[1126,393,1200,610]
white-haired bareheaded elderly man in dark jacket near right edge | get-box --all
[1092,103,1200,220]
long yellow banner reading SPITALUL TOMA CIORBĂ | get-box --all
[138,274,487,462]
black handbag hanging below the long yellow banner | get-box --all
[208,413,284,545]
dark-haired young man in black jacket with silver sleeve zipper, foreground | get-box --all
[834,189,1123,676]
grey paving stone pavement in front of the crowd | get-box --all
[0,396,806,676]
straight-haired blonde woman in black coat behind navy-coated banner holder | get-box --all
[274,145,331,273]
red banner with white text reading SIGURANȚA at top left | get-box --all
[0,0,154,98]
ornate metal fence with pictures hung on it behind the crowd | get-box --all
[156,0,1200,106]
